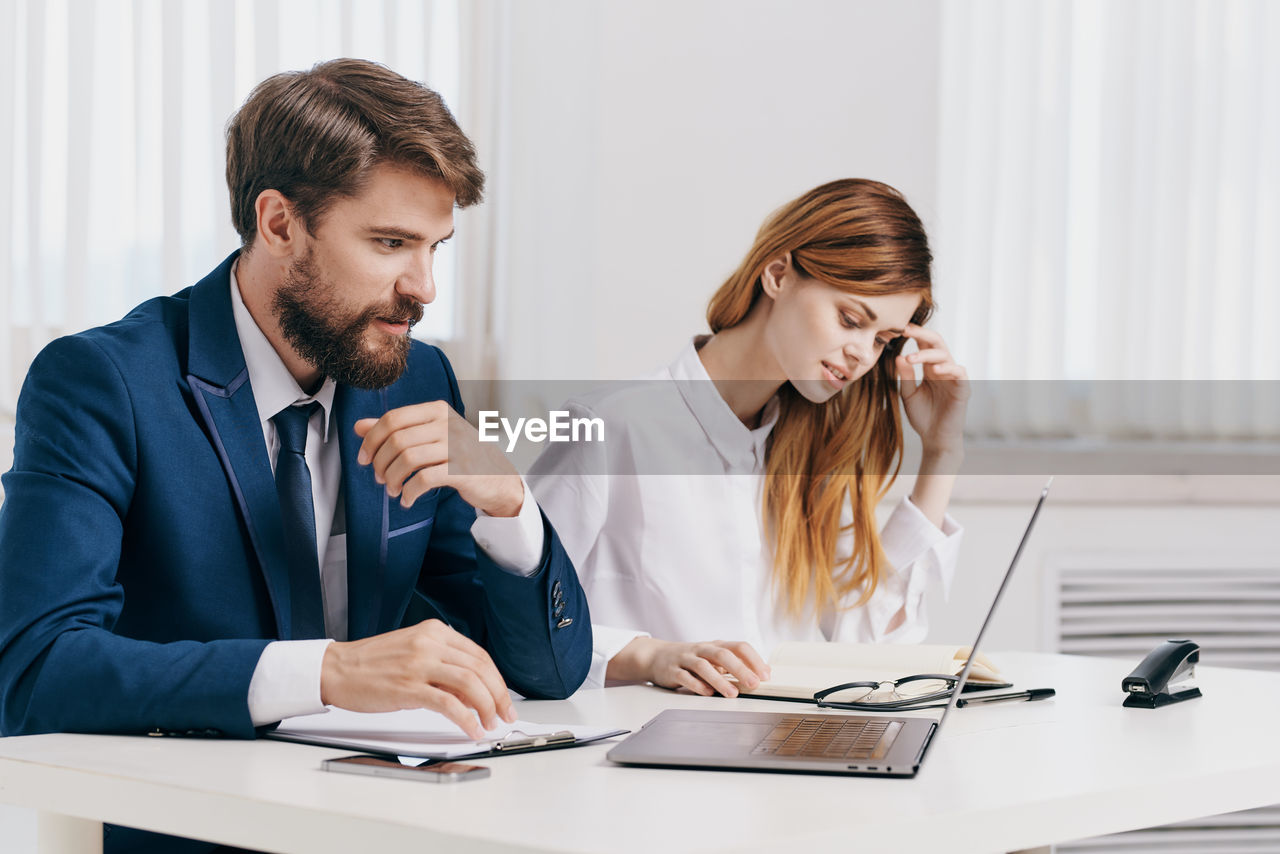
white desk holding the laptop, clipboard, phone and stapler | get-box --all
[0,653,1280,854]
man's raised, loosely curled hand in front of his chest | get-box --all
[356,401,525,516]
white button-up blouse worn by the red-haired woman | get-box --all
[526,341,963,688]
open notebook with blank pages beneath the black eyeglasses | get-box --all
[742,641,1011,702]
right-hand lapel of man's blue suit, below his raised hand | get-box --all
[334,385,389,640]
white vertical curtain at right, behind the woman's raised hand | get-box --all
[936,0,1280,438]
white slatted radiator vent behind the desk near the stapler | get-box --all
[1044,554,1280,854]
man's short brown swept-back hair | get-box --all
[227,59,484,248]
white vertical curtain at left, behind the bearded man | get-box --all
[0,0,471,417]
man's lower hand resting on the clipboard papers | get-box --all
[320,620,516,740]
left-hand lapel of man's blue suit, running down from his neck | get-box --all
[187,254,292,638]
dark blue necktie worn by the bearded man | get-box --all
[271,403,325,639]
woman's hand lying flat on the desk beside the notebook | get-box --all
[607,638,769,697]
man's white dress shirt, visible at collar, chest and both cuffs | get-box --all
[230,265,543,726]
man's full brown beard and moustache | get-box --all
[271,250,422,388]
